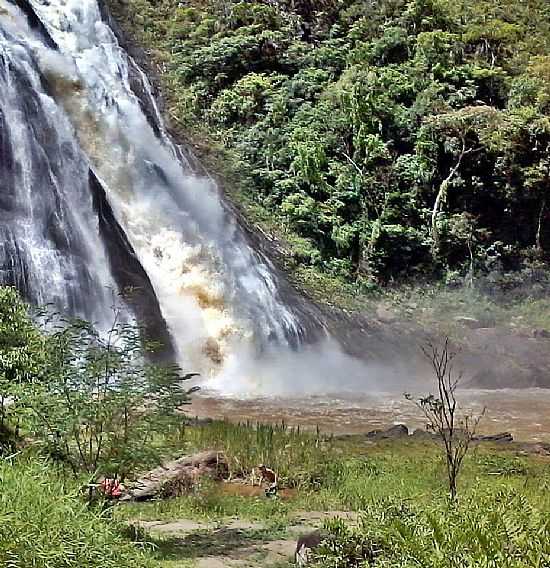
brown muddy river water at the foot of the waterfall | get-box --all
[188,389,550,442]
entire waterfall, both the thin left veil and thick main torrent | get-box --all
[0,0,310,382]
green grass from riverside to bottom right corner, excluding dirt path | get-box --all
[116,422,550,567]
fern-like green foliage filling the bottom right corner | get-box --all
[312,490,550,568]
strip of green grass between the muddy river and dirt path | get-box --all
[118,421,550,524]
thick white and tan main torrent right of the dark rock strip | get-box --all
[0,0,314,388]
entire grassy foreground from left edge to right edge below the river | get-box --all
[4,422,550,568]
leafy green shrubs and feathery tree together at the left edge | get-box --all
[0,287,195,478]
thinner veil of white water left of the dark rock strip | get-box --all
[0,4,115,325]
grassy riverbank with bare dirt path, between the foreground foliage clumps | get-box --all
[115,422,550,568]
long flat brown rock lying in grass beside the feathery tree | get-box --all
[121,451,229,501]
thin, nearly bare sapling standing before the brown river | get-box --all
[405,338,485,499]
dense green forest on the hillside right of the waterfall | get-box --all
[113,0,550,289]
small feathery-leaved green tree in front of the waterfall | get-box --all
[21,309,201,479]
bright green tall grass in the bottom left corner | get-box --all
[0,461,153,568]
